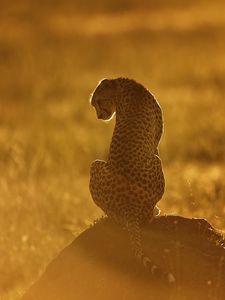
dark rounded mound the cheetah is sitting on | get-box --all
[23,216,225,300]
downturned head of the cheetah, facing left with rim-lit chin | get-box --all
[90,79,116,121]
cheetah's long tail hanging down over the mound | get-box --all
[127,219,175,284]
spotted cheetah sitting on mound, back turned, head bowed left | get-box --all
[89,78,175,283]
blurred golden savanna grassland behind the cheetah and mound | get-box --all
[0,0,225,300]
